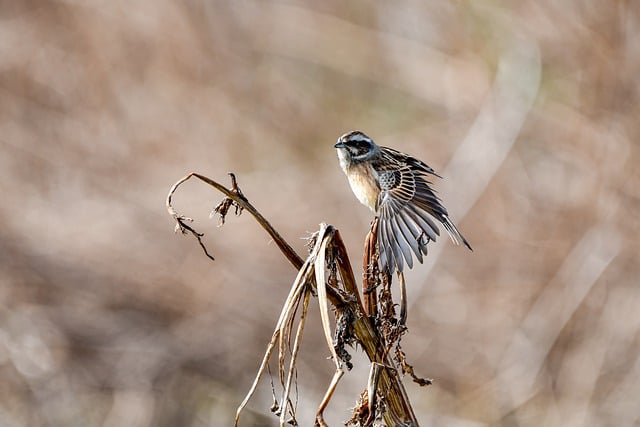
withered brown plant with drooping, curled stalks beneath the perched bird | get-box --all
[167,173,418,426]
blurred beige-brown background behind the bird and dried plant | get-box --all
[0,0,640,427]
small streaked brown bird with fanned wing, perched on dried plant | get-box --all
[335,130,473,274]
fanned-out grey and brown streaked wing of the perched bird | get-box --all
[373,147,471,273]
